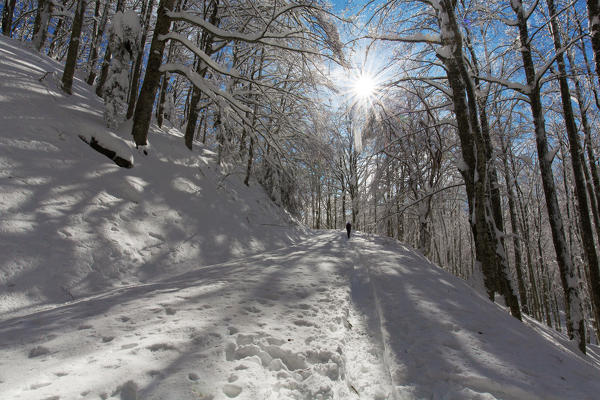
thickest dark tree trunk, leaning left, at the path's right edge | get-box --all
[437,0,521,320]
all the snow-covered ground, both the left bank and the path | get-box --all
[0,37,600,400]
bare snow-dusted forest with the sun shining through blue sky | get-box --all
[0,0,600,353]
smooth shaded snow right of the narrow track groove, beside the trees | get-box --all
[353,238,600,400]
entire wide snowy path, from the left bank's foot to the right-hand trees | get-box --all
[0,232,600,400]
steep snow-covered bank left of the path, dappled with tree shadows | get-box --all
[0,37,308,312]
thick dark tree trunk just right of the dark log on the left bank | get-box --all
[131,0,175,146]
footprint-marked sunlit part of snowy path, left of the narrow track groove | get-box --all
[0,233,391,400]
